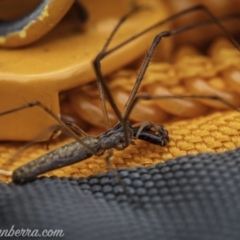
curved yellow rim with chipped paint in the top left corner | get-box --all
[0,0,74,47]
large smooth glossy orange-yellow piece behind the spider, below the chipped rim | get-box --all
[0,0,169,141]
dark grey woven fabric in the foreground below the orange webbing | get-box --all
[0,149,240,240]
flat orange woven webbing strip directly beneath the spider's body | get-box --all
[0,38,240,182]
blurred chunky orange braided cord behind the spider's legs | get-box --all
[68,38,240,128]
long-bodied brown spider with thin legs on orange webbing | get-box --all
[0,5,239,183]
